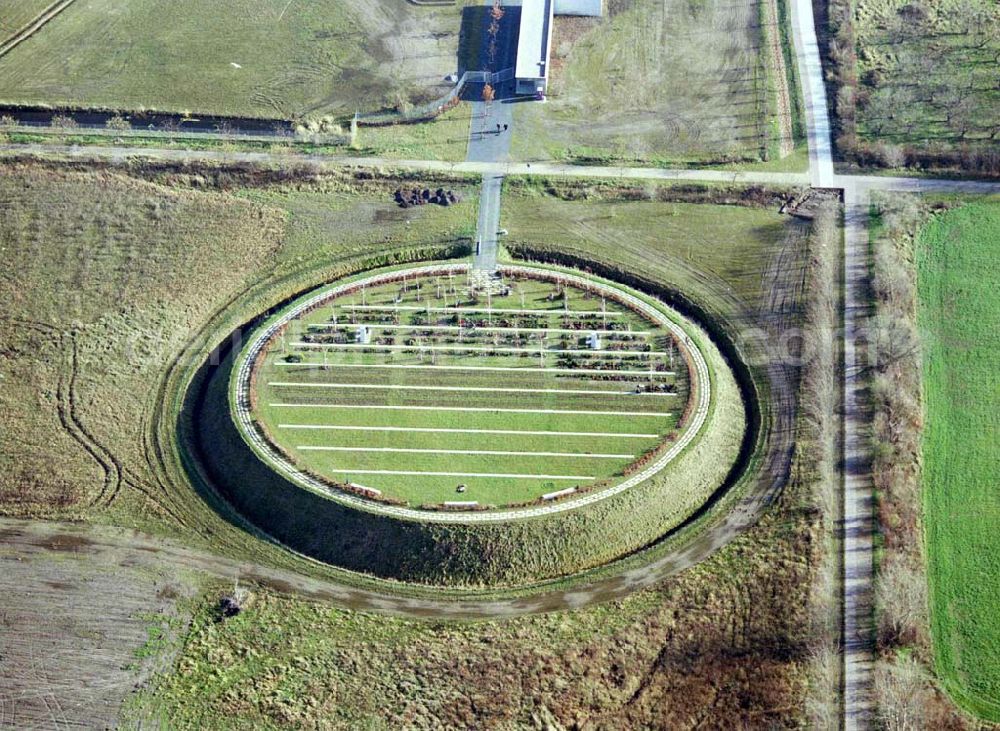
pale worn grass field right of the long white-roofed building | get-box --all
[511,0,768,164]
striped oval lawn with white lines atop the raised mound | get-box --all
[250,277,687,505]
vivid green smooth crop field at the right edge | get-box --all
[917,198,1000,721]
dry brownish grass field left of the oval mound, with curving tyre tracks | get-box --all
[0,166,475,522]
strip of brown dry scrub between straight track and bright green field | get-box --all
[869,194,972,731]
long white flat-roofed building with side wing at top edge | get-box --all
[514,0,604,96]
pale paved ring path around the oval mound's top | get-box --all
[233,264,712,523]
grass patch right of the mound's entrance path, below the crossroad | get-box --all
[503,178,808,318]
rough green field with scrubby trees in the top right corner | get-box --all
[829,0,1000,167]
